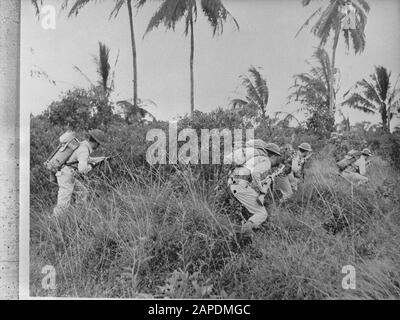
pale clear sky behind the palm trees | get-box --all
[21,0,400,127]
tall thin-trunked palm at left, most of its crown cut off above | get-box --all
[65,0,147,110]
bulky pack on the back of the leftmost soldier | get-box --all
[44,131,80,173]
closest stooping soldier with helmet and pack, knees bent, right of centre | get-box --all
[226,139,271,233]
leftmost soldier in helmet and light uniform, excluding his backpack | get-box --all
[53,129,106,216]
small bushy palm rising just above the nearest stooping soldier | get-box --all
[230,66,269,119]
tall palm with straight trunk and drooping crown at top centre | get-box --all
[143,0,239,116]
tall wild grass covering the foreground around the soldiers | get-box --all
[31,158,400,299]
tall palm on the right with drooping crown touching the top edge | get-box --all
[296,0,370,115]
